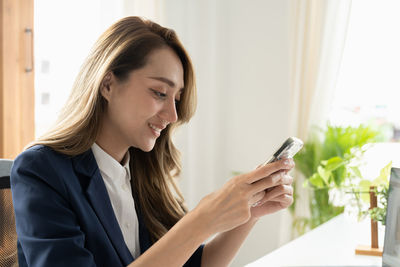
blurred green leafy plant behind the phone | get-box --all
[293,124,382,234]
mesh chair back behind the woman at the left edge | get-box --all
[0,159,18,267]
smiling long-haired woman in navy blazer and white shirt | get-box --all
[11,17,294,267]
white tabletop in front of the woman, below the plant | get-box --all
[246,214,384,267]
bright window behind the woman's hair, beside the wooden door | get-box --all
[34,0,124,137]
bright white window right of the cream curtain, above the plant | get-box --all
[329,0,400,140]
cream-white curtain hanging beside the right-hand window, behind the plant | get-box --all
[288,0,351,238]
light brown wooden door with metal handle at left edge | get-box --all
[0,0,35,159]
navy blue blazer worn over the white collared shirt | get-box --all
[11,145,203,267]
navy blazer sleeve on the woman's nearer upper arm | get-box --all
[11,149,96,267]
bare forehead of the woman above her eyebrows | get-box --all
[137,48,184,89]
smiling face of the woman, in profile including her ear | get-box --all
[100,48,184,154]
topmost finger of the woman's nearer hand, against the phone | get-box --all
[244,159,294,184]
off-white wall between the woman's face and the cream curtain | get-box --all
[164,0,289,266]
